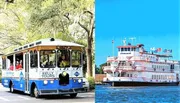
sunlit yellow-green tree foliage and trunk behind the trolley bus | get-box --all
[0,0,95,76]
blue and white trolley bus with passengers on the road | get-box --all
[2,38,85,98]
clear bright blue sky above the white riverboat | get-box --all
[95,0,180,65]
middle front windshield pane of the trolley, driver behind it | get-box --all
[57,50,70,68]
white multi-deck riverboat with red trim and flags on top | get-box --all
[103,40,180,86]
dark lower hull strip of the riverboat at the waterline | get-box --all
[105,81,179,86]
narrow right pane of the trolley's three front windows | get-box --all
[71,50,81,67]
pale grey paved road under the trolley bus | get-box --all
[0,84,94,103]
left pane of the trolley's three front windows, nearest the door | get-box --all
[40,50,56,68]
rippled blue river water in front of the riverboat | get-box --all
[95,85,180,103]
